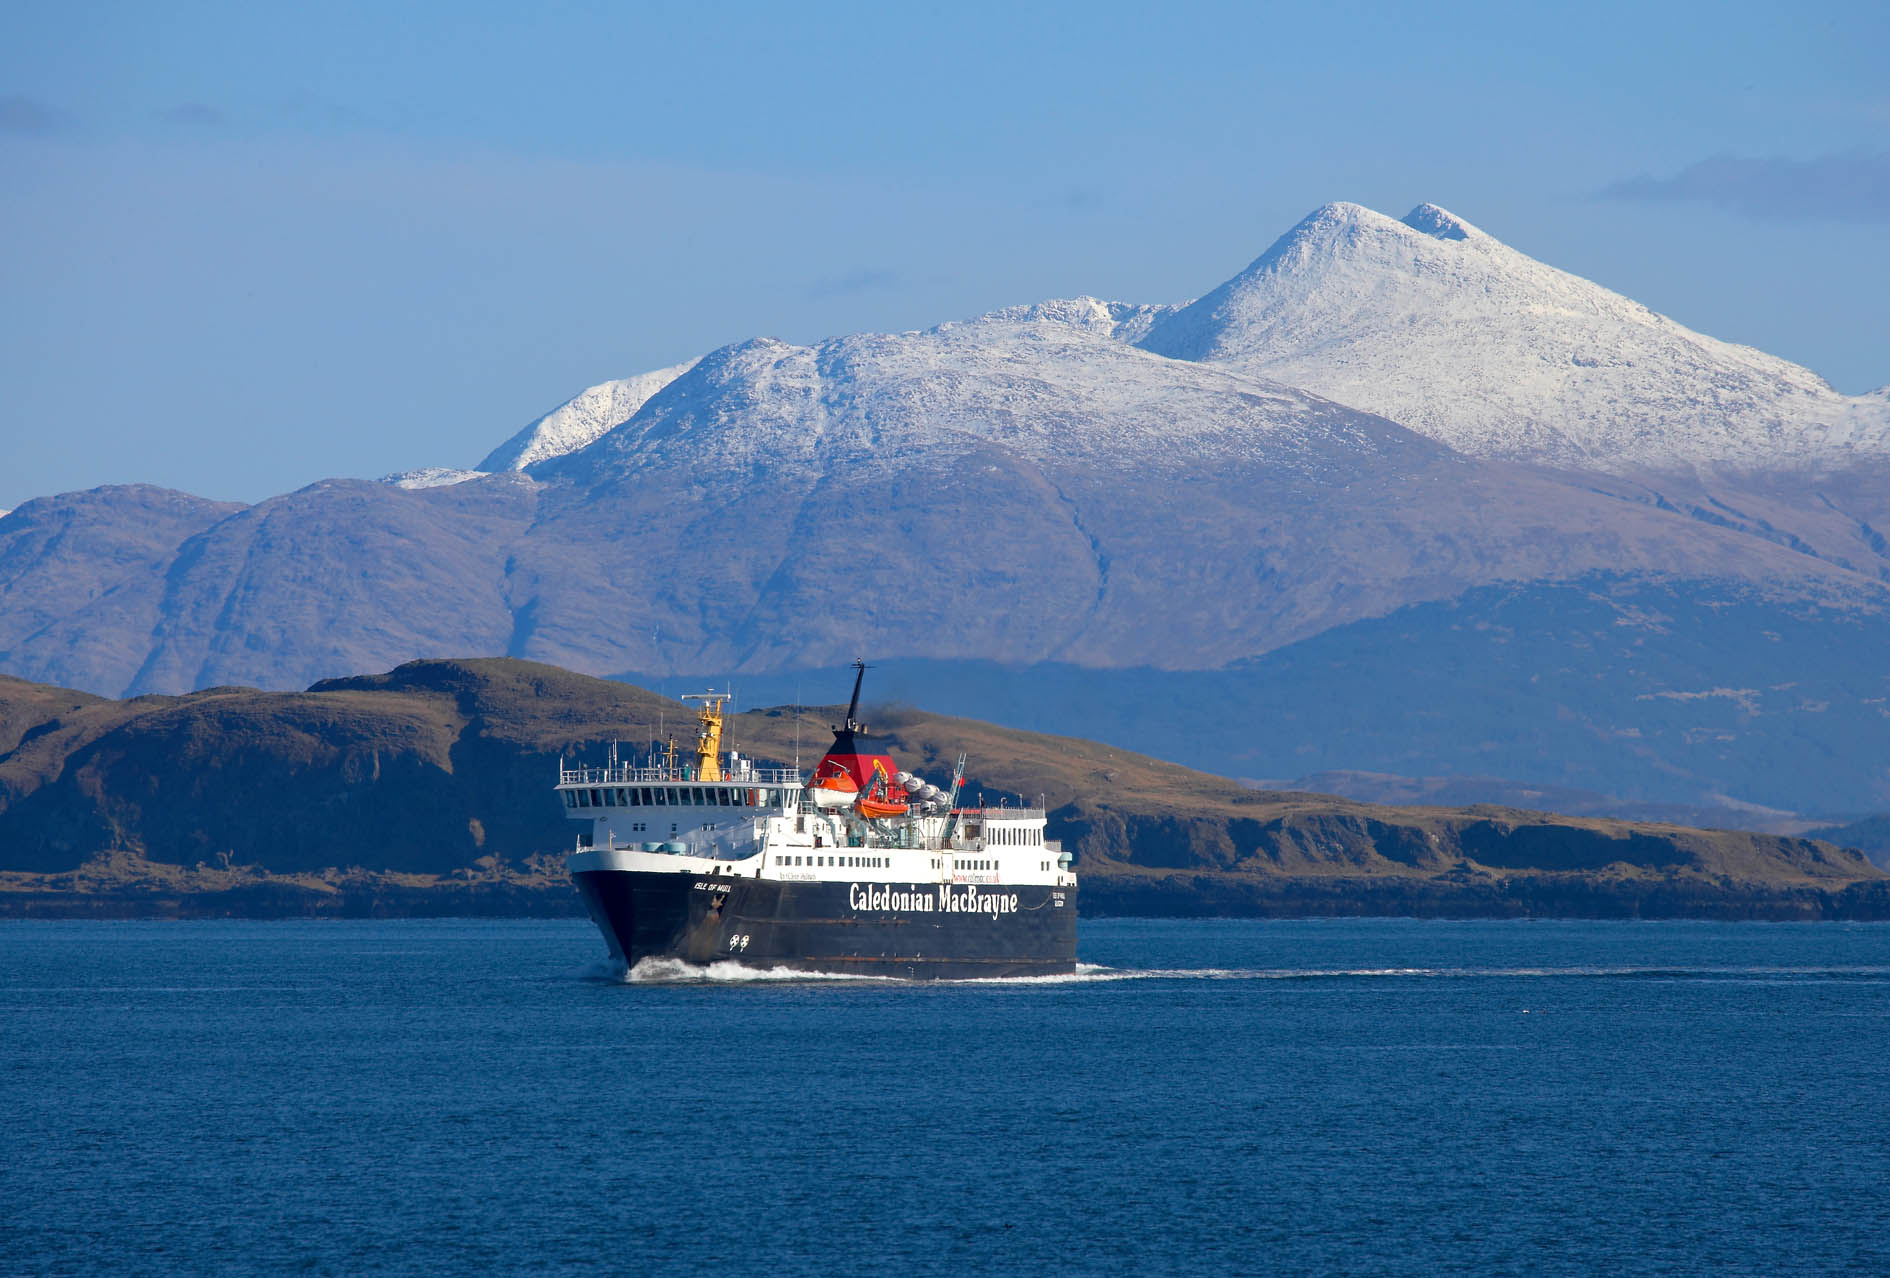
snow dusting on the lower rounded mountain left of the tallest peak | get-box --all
[551,308,1444,495]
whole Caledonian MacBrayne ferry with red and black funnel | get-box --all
[558,662,1075,981]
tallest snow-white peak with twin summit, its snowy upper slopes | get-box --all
[1142,204,1890,471]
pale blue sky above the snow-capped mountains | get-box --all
[0,0,1890,507]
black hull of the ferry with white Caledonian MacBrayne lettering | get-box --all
[571,870,1075,981]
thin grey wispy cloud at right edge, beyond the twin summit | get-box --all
[1601,149,1890,223]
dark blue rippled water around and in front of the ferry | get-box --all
[0,921,1890,1278]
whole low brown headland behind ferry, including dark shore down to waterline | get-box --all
[0,658,1890,919]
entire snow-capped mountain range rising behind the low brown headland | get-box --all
[0,206,1890,820]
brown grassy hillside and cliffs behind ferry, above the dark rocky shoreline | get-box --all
[0,660,1884,890]
